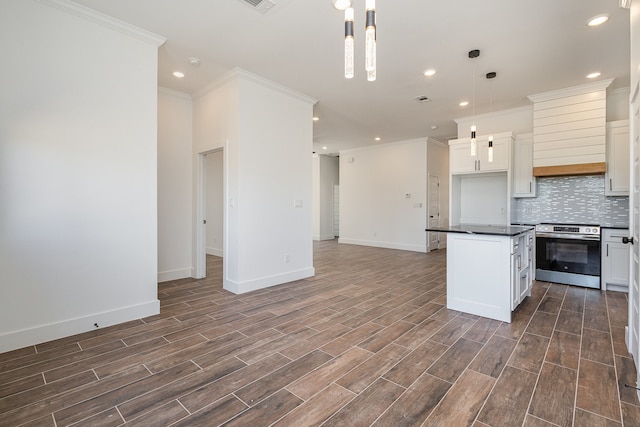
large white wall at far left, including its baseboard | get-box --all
[0,0,163,352]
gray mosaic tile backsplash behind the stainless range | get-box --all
[511,175,629,227]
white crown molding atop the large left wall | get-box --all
[36,0,167,47]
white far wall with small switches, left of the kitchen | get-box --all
[339,138,430,252]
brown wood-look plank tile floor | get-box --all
[0,241,640,427]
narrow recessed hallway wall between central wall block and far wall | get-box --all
[313,154,340,240]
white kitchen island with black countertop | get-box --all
[426,225,534,322]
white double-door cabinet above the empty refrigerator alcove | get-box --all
[449,132,513,175]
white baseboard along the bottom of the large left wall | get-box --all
[0,300,160,353]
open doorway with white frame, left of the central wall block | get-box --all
[194,148,227,279]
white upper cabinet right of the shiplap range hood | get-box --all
[604,120,629,196]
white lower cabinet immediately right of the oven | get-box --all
[600,228,630,292]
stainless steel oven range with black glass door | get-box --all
[536,224,600,289]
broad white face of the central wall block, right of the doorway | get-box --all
[232,73,315,293]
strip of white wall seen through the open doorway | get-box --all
[206,150,224,257]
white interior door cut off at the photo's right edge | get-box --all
[627,86,640,367]
